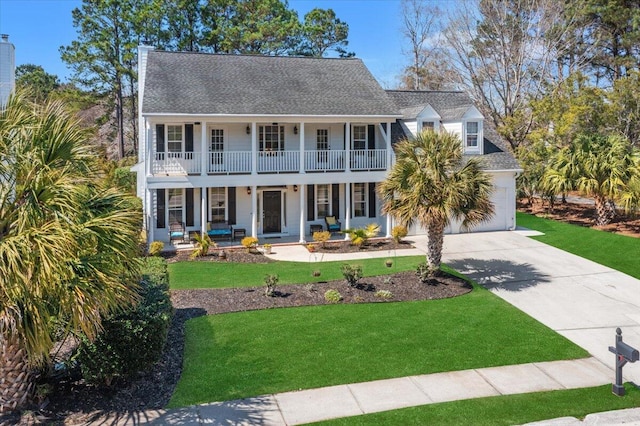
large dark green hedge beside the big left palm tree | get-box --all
[75,257,173,386]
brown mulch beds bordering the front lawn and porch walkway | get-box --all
[6,240,471,425]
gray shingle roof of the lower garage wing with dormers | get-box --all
[387,90,521,170]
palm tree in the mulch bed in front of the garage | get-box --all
[378,131,493,275]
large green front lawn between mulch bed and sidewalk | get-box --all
[169,278,588,407]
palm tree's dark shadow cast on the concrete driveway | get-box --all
[447,259,550,291]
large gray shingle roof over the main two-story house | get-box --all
[142,51,399,116]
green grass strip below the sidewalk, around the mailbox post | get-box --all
[315,384,640,426]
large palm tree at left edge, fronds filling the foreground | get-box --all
[0,94,140,412]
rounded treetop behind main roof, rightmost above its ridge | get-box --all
[298,8,354,58]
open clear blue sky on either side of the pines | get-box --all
[0,0,453,88]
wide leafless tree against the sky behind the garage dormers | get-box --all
[444,0,584,149]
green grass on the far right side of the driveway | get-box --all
[516,212,640,279]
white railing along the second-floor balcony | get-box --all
[150,149,388,175]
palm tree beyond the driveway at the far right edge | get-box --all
[543,134,635,226]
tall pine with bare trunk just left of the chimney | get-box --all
[60,0,139,158]
